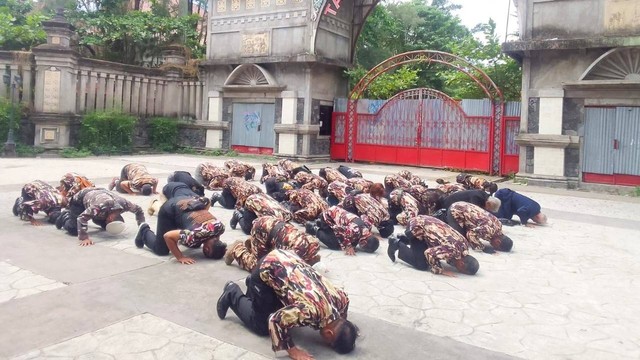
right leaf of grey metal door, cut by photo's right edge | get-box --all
[613,107,640,175]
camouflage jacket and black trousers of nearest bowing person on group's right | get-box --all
[398,215,469,274]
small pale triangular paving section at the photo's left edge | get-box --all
[0,261,66,303]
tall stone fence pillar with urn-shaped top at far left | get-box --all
[31,9,79,148]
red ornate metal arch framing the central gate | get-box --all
[345,50,504,173]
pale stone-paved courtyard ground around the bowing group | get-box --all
[0,155,640,360]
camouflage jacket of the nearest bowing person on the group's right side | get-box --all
[407,215,469,274]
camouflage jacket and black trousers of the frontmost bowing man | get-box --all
[221,250,349,351]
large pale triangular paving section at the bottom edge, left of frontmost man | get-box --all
[13,314,266,360]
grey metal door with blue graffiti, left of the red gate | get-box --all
[231,103,275,148]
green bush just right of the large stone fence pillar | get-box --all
[78,111,137,155]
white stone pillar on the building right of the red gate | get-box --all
[533,89,564,177]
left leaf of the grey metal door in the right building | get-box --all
[582,108,616,175]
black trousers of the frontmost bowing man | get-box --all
[230,262,283,336]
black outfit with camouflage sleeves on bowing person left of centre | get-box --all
[141,182,225,255]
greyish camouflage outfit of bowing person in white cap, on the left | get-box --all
[64,188,145,240]
